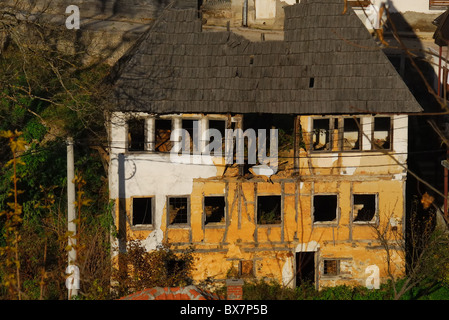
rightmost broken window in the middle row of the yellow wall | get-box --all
[352,193,379,224]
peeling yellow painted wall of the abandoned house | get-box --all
[112,117,406,287]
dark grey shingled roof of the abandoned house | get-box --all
[107,0,422,114]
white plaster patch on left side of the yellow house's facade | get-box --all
[109,113,217,250]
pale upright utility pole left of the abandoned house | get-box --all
[66,137,79,300]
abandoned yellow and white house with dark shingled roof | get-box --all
[109,0,422,288]
